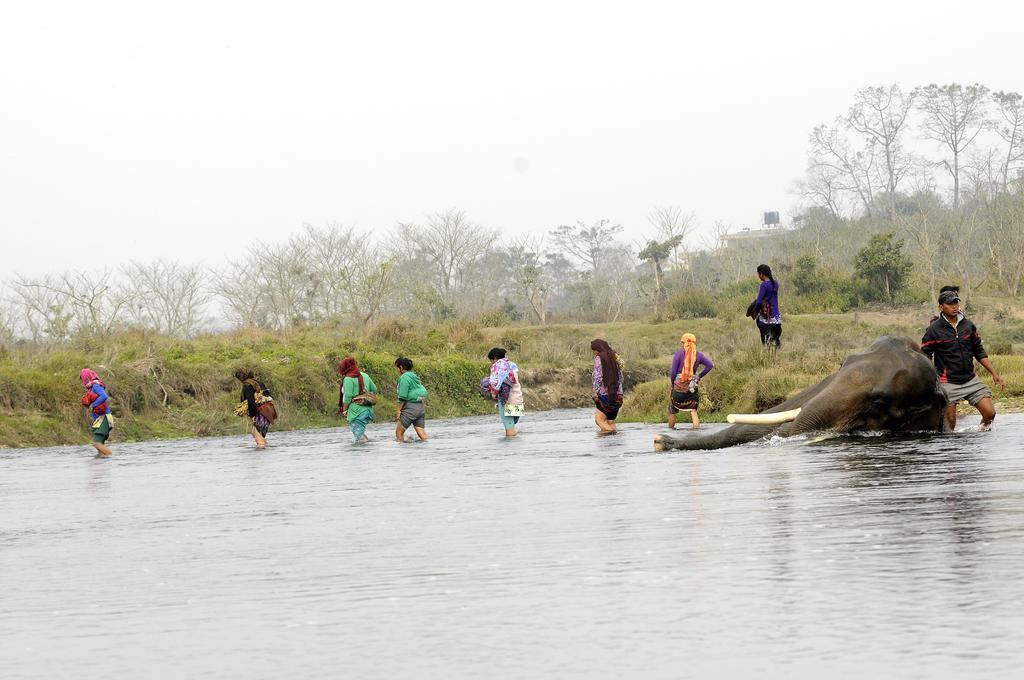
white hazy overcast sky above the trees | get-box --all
[0,0,1024,274]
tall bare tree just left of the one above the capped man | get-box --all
[845,83,913,219]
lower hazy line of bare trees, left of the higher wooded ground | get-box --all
[0,208,693,345]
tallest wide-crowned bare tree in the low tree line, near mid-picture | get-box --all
[398,208,497,302]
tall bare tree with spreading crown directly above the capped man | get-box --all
[913,83,989,209]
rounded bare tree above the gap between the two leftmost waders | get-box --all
[122,260,210,337]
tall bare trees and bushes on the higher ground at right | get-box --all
[778,83,1024,302]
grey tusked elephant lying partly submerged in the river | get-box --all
[654,335,946,451]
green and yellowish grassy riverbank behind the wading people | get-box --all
[0,304,1024,447]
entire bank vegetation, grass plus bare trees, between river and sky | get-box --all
[6,83,1024,445]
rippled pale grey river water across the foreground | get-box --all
[0,411,1024,680]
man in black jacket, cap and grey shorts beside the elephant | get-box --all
[921,290,1006,430]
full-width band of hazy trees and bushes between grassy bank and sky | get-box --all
[8,83,1024,344]
